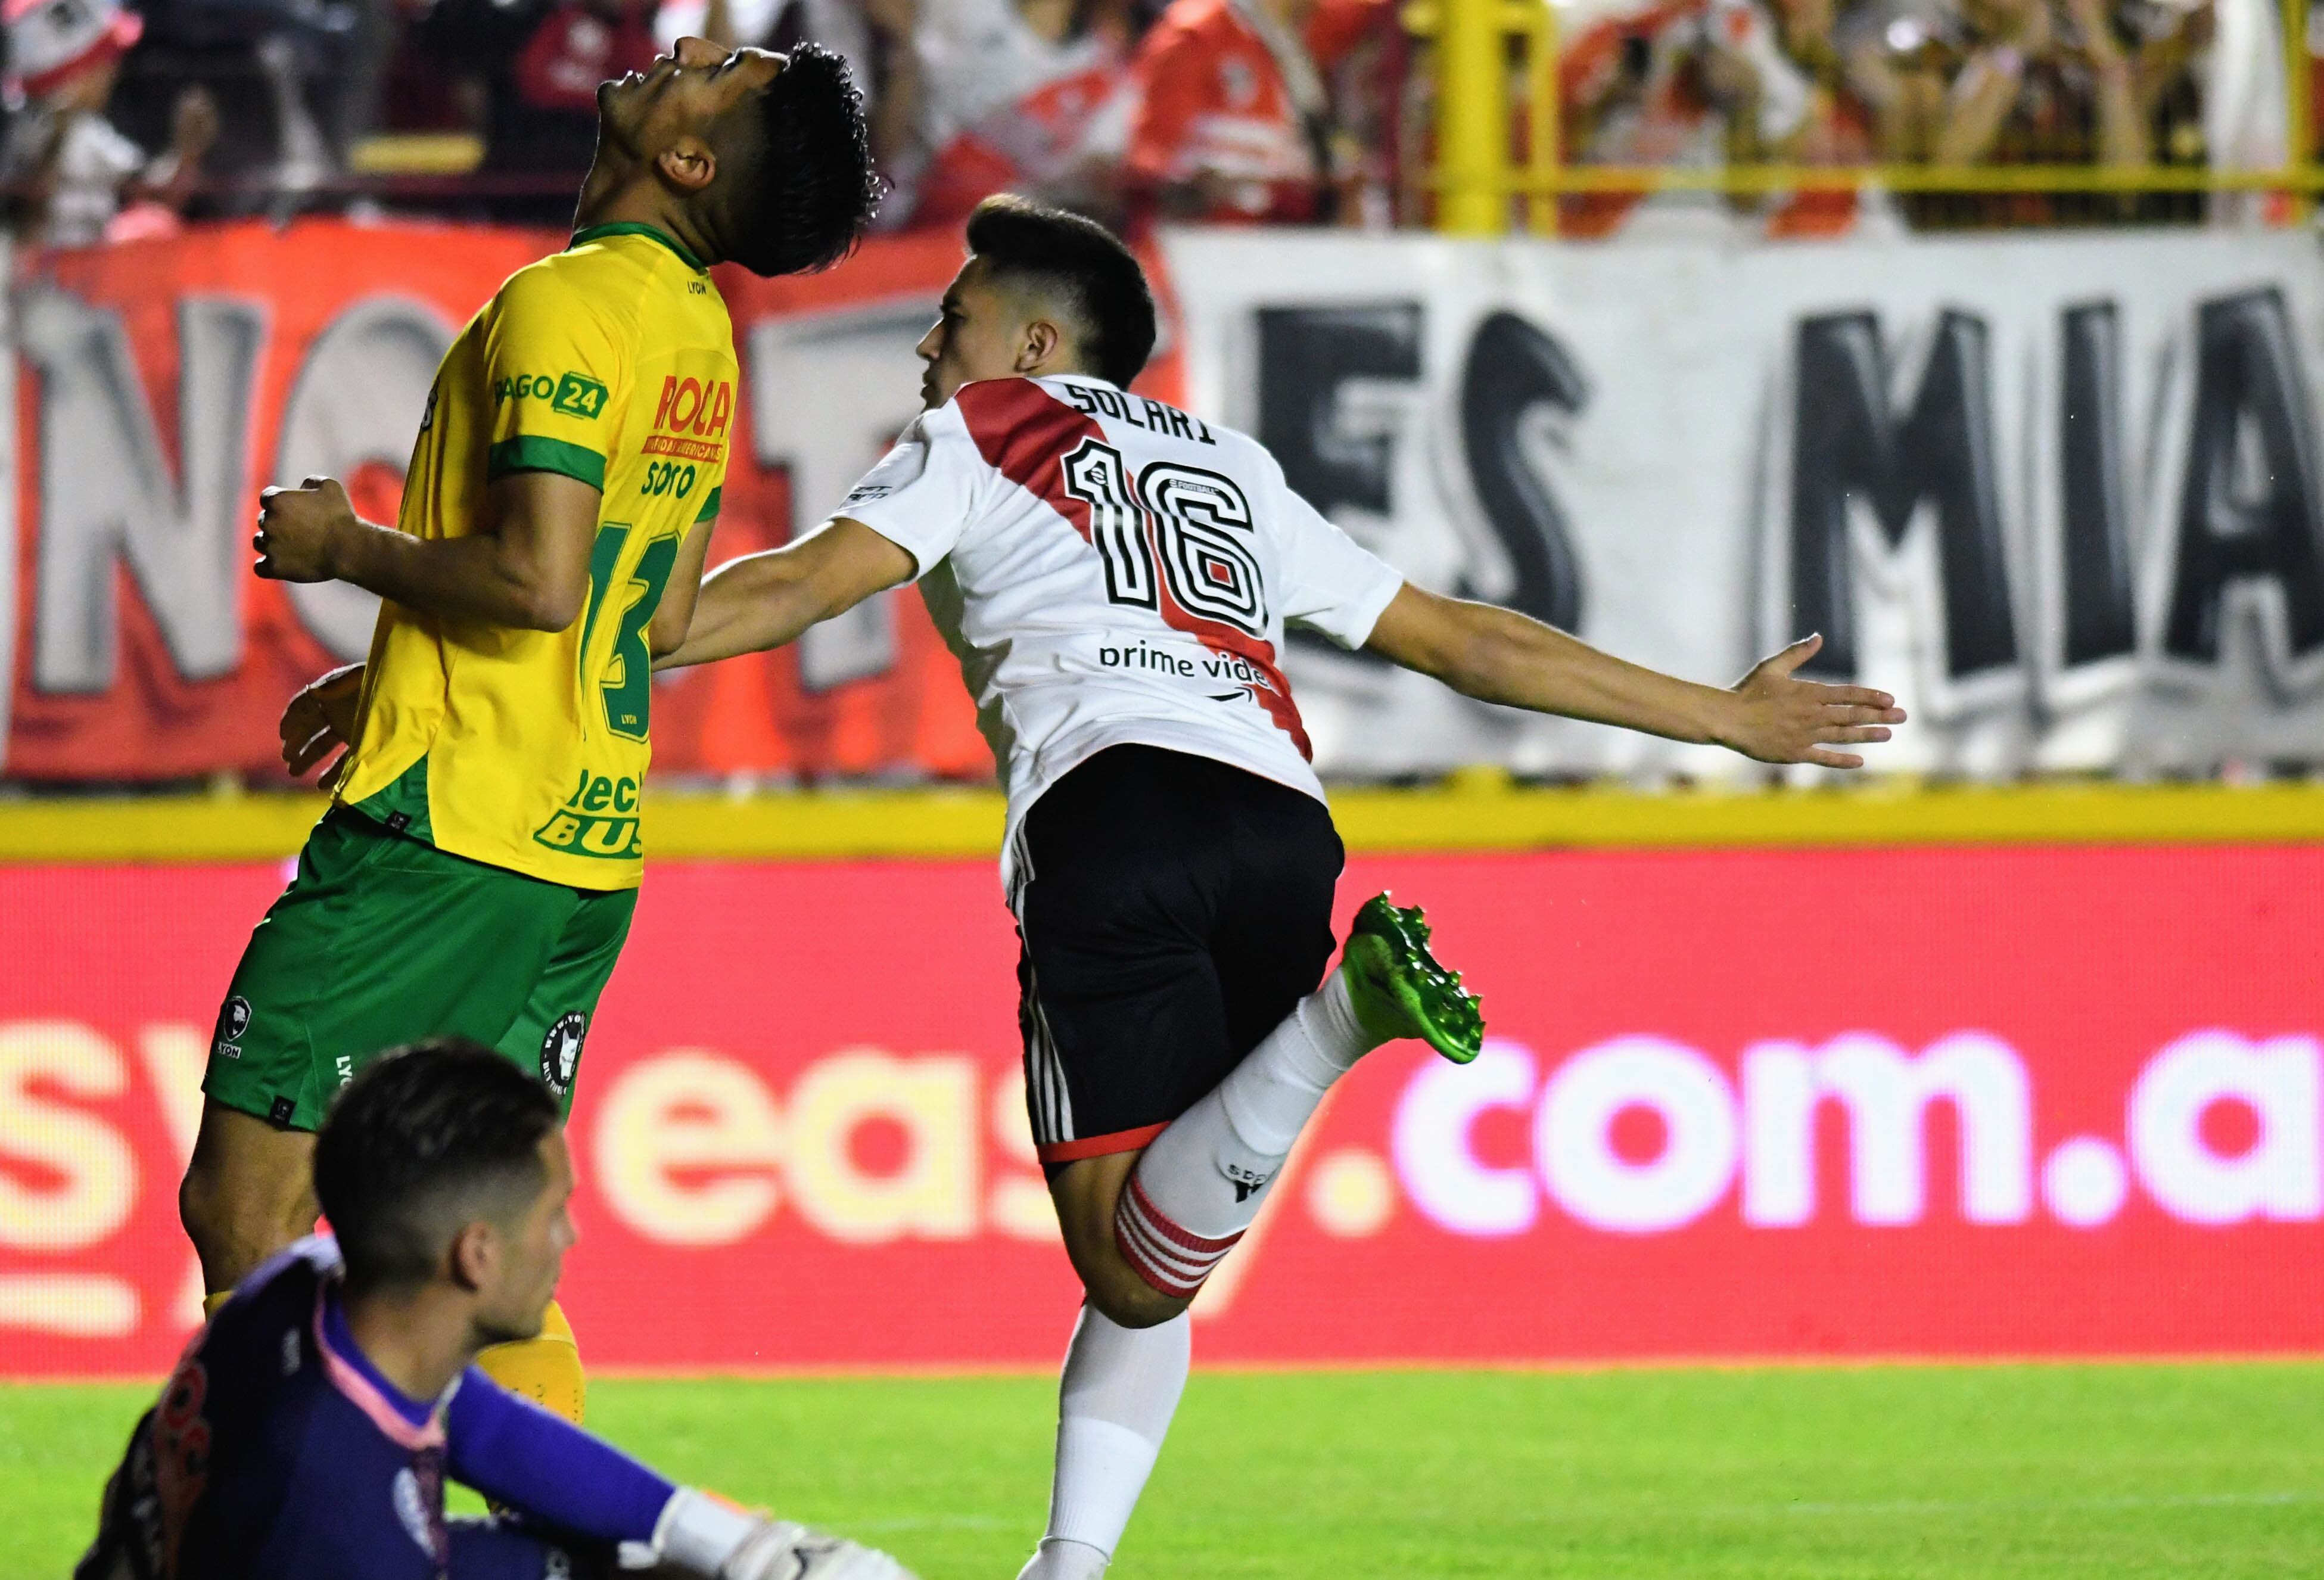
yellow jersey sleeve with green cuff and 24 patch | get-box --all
[483,268,634,490]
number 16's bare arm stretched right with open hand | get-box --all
[1364,583,1903,769]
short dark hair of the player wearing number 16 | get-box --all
[969,193,1155,385]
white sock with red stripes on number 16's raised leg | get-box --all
[1113,971,1380,1296]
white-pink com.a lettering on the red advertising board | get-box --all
[1390,1030,2324,1239]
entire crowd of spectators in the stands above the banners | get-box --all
[0,0,2324,246]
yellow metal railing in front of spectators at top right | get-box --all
[1401,0,2324,235]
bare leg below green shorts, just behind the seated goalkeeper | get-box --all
[176,1102,316,1296]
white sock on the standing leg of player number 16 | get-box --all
[1018,1306,1192,1580]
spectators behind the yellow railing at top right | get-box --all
[1560,0,2286,230]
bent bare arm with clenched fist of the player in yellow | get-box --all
[251,472,602,632]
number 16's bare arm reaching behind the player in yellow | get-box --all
[653,516,913,669]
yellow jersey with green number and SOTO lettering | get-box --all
[337,225,737,890]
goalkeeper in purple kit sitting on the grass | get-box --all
[74,1038,911,1580]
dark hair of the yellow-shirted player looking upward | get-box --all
[704,44,888,274]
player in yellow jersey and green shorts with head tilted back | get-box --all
[179,39,879,1417]
